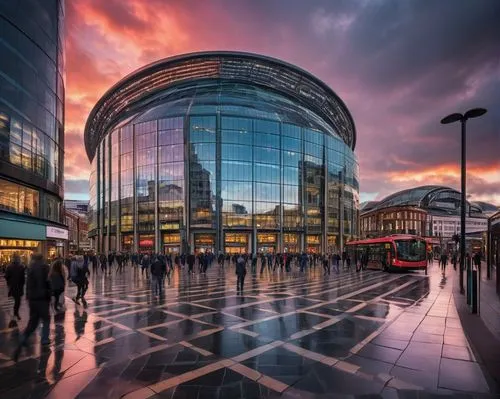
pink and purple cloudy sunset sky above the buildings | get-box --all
[65,0,500,205]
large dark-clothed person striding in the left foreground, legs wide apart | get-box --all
[13,254,50,362]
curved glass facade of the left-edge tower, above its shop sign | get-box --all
[0,0,64,216]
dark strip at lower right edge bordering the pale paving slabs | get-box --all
[453,285,500,394]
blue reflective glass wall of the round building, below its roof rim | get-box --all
[93,90,359,253]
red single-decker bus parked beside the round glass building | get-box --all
[346,235,427,274]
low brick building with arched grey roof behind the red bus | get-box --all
[360,186,493,241]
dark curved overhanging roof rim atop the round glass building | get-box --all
[84,51,356,160]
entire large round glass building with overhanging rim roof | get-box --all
[85,52,359,253]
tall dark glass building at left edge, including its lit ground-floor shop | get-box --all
[0,0,68,263]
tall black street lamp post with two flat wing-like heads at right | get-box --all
[441,108,486,294]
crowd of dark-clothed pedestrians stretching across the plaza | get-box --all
[5,245,482,360]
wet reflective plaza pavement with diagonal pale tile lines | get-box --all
[0,265,493,399]
